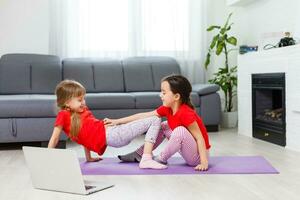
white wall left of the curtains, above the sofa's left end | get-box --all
[0,0,49,56]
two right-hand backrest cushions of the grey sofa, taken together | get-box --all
[62,57,180,92]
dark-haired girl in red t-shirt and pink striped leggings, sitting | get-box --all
[107,75,210,170]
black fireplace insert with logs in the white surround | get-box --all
[252,73,286,146]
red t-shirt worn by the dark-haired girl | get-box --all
[156,104,210,149]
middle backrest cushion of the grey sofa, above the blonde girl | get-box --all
[63,58,124,92]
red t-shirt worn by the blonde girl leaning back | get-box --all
[54,109,106,155]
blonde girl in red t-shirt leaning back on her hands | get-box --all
[48,80,167,169]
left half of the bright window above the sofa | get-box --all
[79,0,128,51]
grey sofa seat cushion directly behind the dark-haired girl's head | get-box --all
[130,92,200,109]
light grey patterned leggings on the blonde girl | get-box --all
[106,116,161,147]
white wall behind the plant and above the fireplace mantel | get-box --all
[206,0,300,111]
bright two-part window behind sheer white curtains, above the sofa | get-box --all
[77,0,189,52]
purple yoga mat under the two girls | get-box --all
[80,156,279,175]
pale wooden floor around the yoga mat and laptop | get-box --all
[0,129,300,200]
